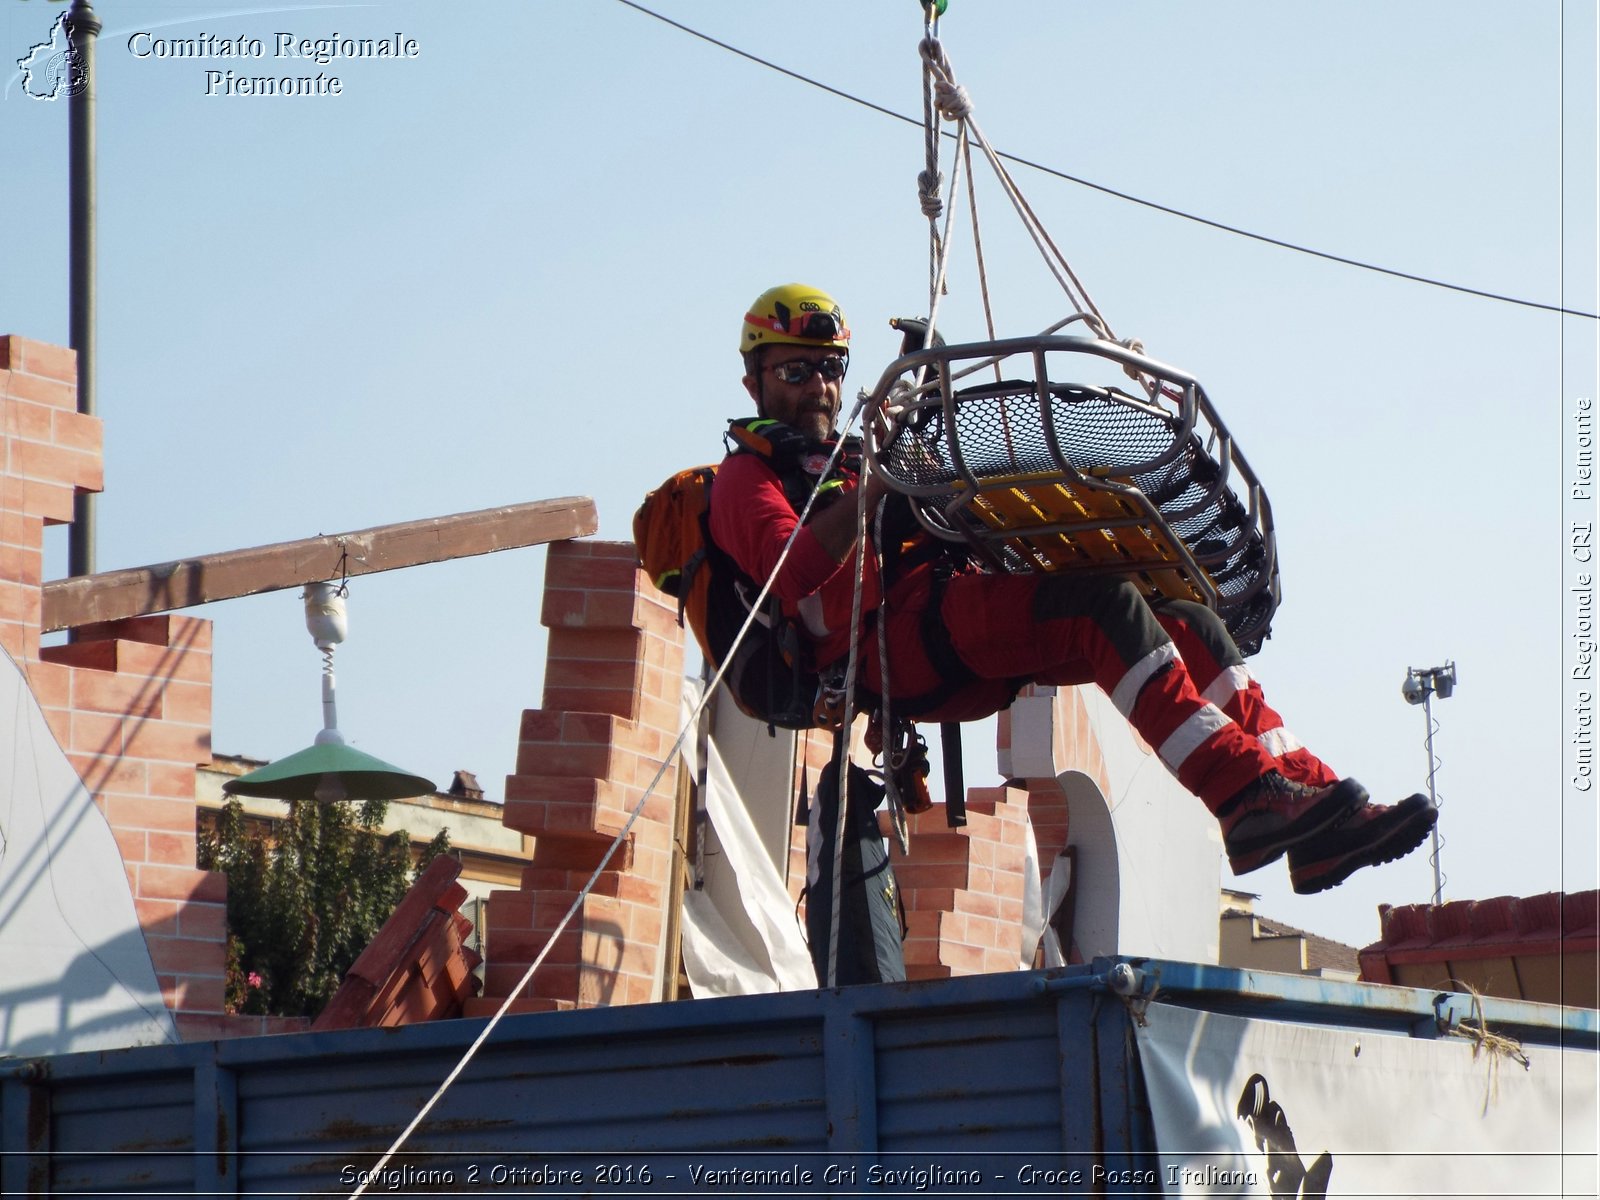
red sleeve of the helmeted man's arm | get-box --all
[710,454,848,603]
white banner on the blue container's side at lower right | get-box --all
[1138,1003,1597,1197]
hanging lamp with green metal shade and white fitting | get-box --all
[222,584,435,803]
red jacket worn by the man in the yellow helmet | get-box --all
[710,454,878,667]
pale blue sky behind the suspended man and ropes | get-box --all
[0,0,1595,944]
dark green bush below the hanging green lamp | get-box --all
[197,798,450,1016]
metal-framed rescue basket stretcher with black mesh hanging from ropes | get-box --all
[867,336,1282,654]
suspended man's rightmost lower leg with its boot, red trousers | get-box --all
[1155,600,1437,894]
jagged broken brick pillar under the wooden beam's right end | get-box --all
[466,541,683,1016]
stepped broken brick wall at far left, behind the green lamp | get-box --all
[0,336,237,1037]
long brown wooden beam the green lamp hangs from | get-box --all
[40,496,598,634]
